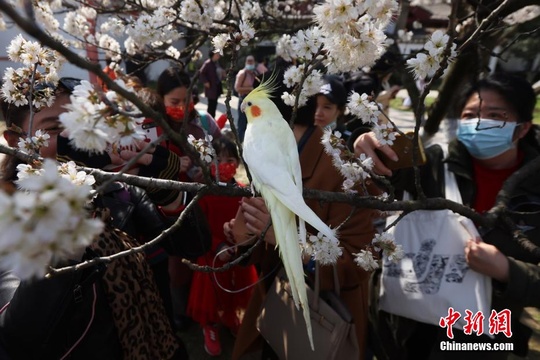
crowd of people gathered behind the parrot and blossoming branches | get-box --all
[0,45,540,360]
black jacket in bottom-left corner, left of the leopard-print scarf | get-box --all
[0,255,122,360]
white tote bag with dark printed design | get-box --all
[379,142,491,329]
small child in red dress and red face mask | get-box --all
[188,137,257,356]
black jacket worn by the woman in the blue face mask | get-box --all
[392,140,540,354]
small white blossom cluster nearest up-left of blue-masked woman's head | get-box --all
[407,30,457,79]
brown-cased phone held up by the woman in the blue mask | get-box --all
[375,131,426,170]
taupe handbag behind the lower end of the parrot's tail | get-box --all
[257,263,359,360]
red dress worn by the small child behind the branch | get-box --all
[187,190,258,331]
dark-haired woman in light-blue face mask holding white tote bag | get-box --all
[354,74,540,360]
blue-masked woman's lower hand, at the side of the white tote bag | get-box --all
[465,240,510,282]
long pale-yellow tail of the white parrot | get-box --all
[262,191,315,350]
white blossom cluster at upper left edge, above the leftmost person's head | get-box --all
[2,34,62,109]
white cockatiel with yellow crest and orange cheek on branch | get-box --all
[241,78,337,349]
